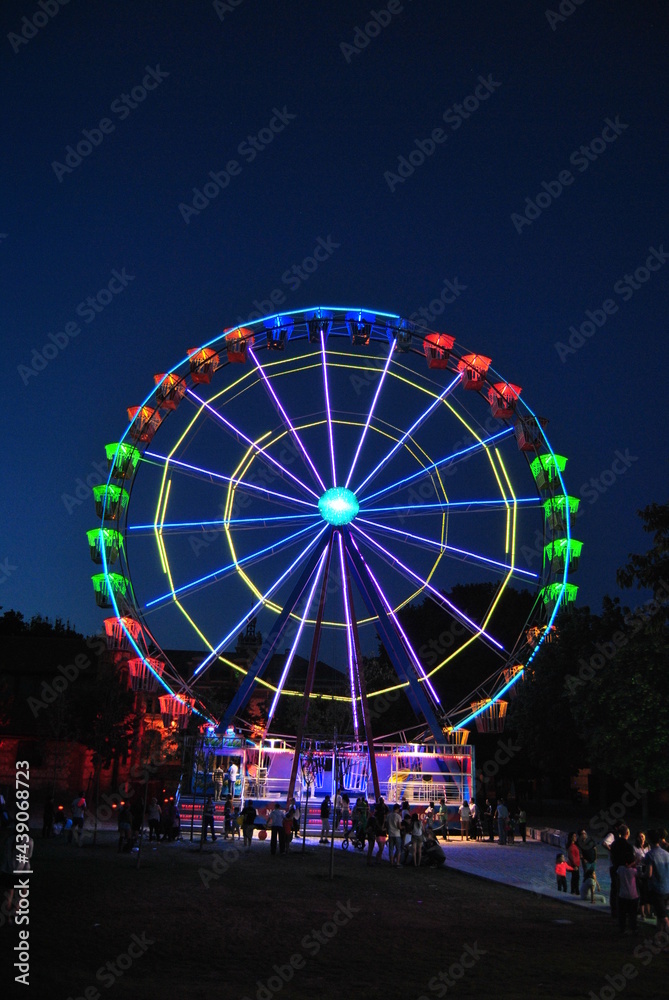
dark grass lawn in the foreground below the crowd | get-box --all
[6,833,669,1000]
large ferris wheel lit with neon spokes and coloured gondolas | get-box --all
[88,307,581,742]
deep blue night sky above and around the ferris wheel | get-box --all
[0,0,669,644]
